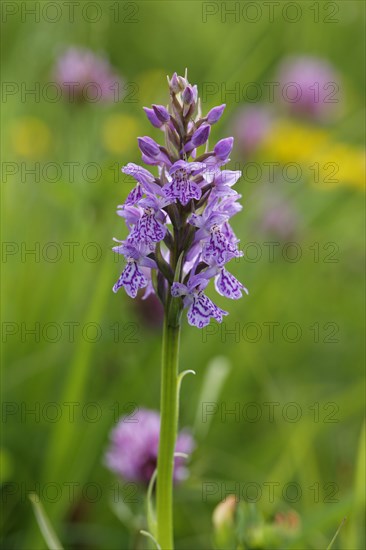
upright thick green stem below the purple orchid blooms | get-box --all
[156,315,180,550]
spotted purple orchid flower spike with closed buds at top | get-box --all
[113,69,248,328]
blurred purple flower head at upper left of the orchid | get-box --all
[54,47,122,103]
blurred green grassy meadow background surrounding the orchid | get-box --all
[1,1,365,550]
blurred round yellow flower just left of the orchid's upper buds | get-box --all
[102,114,141,155]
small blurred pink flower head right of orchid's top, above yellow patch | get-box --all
[233,105,273,154]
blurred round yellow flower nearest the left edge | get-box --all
[10,117,51,160]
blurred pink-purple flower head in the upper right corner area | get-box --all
[277,56,340,120]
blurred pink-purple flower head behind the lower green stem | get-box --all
[105,409,194,485]
